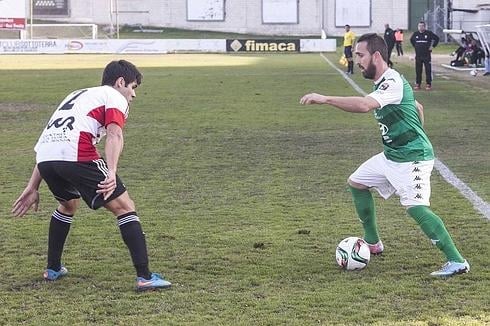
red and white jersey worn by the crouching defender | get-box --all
[34,86,129,163]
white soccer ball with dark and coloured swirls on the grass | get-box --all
[335,237,371,271]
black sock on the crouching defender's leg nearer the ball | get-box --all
[117,212,151,279]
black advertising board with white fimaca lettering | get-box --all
[226,39,300,52]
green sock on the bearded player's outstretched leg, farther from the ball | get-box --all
[407,206,464,263]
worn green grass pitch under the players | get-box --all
[0,54,490,325]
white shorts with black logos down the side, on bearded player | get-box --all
[349,153,434,206]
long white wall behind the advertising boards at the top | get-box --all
[51,0,409,36]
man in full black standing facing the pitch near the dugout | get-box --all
[410,21,439,90]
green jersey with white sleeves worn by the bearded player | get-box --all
[368,69,434,162]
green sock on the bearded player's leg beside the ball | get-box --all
[349,186,379,244]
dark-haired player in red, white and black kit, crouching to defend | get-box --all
[12,60,171,291]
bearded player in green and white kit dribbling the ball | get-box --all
[300,33,470,277]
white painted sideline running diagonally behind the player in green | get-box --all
[320,53,490,220]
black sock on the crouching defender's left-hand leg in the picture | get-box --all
[48,210,73,271]
